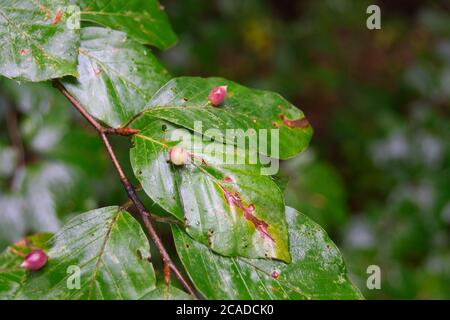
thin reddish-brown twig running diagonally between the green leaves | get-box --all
[53,80,197,297]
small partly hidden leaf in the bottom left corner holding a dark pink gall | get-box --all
[0,233,51,300]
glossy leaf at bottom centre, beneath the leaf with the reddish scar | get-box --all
[172,207,362,299]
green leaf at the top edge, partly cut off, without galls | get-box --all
[80,0,177,49]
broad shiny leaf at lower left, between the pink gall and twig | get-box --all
[17,207,156,299]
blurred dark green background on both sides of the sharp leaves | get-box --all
[0,0,450,299]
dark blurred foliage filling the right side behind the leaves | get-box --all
[162,0,450,298]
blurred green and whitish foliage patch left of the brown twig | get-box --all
[0,80,125,248]
